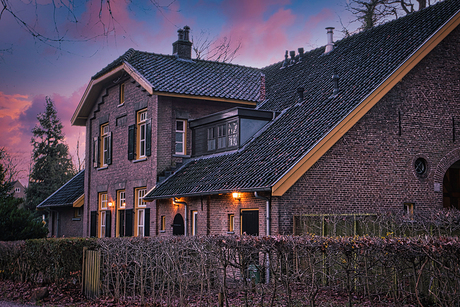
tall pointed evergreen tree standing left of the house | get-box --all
[26,97,75,211]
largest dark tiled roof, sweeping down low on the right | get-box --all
[145,0,460,199]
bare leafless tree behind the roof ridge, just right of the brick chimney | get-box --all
[192,30,241,63]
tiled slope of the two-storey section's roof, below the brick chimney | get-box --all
[92,48,261,102]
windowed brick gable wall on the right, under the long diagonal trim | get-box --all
[273,28,460,233]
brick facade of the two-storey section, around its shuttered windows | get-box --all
[83,79,255,237]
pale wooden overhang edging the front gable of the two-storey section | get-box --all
[70,63,153,126]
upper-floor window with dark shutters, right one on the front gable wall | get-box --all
[128,109,152,160]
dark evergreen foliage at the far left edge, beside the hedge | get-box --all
[0,150,48,241]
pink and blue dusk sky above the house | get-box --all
[0,0,357,183]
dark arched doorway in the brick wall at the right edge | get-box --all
[442,160,460,209]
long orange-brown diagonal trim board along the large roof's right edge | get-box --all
[272,12,460,196]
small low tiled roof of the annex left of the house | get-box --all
[37,170,85,209]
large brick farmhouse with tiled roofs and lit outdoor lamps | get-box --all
[37,0,460,237]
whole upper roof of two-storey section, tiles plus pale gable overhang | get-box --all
[71,49,263,125]
